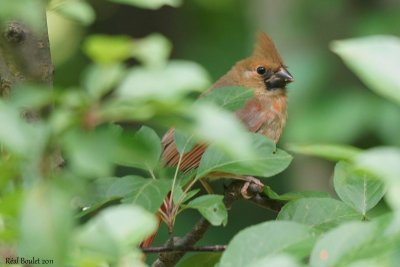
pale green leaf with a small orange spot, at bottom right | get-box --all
[310,222,376,267]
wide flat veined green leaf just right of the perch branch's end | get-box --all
[277,198,362,231]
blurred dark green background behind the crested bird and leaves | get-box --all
[49,0,400,260]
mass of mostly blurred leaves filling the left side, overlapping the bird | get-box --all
[0,1,291,266]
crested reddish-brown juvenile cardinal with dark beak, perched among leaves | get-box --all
[142,33,293,247]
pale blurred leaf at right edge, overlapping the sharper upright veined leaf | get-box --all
[355,147,400,209]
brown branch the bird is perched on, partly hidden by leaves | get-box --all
[149,181,284,267]
